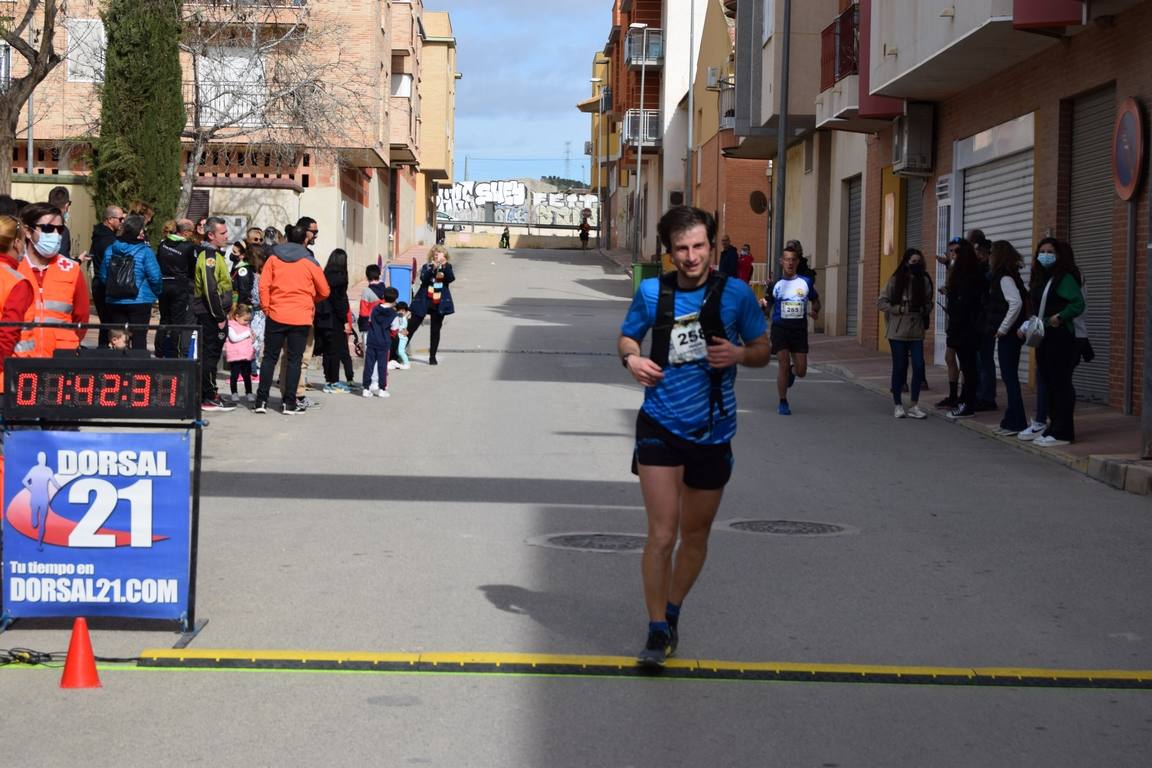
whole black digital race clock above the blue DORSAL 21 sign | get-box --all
[3,355,200,421]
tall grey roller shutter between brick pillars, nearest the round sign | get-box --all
[1068,88,1116,403]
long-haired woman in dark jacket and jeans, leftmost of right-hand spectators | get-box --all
[876,248,932,419]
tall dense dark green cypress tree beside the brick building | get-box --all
[91,0,185,221]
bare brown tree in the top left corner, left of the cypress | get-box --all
[0,0,67,193]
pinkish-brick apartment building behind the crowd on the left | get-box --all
[0,0,454,279]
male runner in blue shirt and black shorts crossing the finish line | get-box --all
[616,206,770,668]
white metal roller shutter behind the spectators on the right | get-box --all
[960,150,1032,381]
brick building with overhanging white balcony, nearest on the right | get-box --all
[859,0,1152,412]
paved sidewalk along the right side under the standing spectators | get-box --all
[600,249,1152,495]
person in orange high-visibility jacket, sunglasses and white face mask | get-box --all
[14,203,89,357]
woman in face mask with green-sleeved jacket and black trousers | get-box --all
[1029,237,1084,447]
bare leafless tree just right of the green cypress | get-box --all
[177,0,370,216]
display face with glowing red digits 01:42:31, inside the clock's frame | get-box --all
[16,372,182,409]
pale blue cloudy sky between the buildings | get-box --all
[435,0,613,181]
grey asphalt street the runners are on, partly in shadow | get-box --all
[0,251,1152,768]
